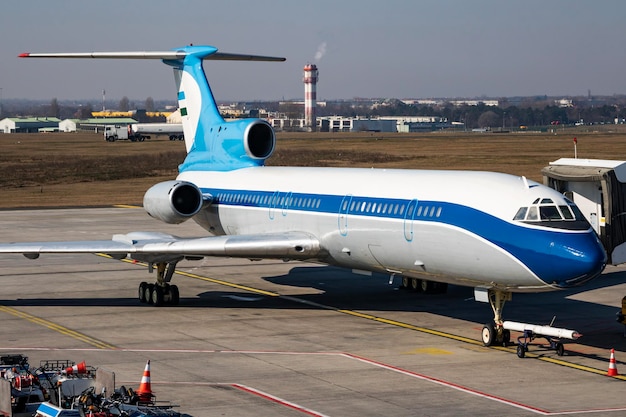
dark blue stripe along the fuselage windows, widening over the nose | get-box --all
[202,189,606,287]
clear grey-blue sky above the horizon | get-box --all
[0,0,626,100]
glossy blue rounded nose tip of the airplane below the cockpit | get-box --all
[548,231,607,288]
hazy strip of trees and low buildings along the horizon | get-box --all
[0,96,626,129]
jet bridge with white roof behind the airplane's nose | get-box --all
[541,158,626,265]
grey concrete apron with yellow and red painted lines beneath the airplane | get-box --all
[0,207,626,417]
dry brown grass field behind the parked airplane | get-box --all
[0,130,626,208]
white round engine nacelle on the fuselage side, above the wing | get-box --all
[143,181,203,224]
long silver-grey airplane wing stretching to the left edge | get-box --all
[0,232,321,262]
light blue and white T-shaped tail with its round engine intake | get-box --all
[20,46,285,172]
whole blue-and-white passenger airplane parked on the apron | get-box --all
[0,45,607,346]
